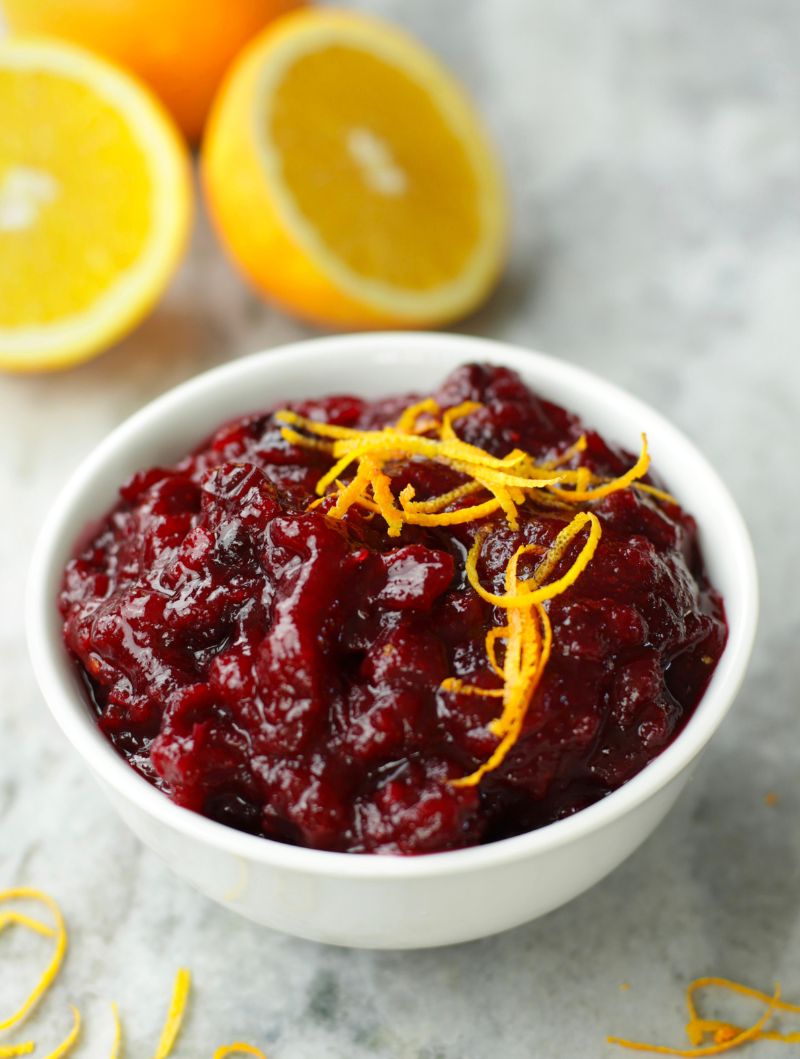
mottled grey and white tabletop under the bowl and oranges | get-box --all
[0,0,800,1059]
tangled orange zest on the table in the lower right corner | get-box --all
[608,977,800,1059]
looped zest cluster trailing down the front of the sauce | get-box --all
[441,511,602,787]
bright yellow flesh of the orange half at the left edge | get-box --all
[0,69,153,327]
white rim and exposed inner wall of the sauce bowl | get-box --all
[28,334,758,875]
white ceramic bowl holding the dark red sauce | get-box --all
[28,334,758,948]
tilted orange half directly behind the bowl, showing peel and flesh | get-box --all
[202,10,506,327]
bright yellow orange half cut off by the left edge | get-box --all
[0,39,192,371]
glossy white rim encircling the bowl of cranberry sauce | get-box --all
[26,333,758,880]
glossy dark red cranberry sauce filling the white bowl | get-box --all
[59,364,727,854]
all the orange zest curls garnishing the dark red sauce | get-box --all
[275,397,652,787]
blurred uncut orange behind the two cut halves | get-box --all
[0,0,305,140]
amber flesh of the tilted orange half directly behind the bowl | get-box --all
[268,44,481,291]
